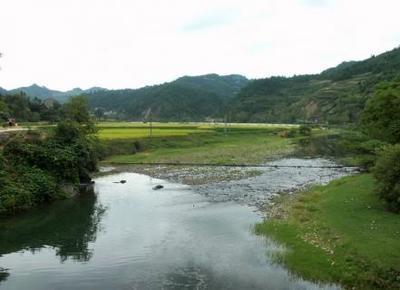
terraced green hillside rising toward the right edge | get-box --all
[229,48,400,123]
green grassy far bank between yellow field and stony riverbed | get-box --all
[103,128,295,164]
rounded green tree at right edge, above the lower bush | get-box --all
[361,78,400,144]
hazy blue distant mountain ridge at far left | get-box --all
[6,84,105,103]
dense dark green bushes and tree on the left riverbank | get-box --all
[0,98,98,214]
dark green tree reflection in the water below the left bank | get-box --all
[0,186,105,262]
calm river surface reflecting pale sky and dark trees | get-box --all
[0,161,354,290]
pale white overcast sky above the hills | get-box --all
[0,0,400,90]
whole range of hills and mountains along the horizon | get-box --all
[5,48,400,124]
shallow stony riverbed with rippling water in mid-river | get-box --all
[102,158,357,208]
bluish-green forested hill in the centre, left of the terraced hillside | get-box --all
[86,74,248,121]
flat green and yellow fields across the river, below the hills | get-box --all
[99,123,297,164]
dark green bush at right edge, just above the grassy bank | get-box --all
[373,144,400,213]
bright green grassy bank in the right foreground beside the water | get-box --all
[256,174,400,289]
